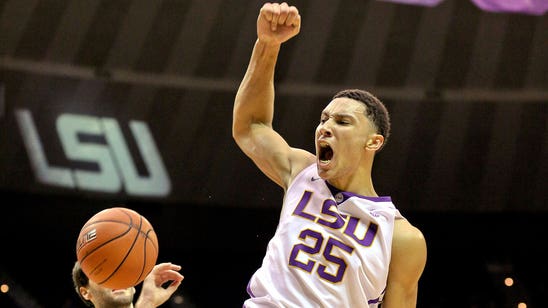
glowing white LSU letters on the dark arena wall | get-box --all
[15,109,171,197]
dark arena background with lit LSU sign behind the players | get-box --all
[0,0,548,308]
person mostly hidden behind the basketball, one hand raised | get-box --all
[72,261,184,308]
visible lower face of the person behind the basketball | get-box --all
[83,280,135,308]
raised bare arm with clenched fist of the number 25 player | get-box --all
[232,2,313,188]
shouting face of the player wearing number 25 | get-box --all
[316,97,378,180]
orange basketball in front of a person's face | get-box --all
[76,207,158,289]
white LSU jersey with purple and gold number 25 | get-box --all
[244,164,403,308]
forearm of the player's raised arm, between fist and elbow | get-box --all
[233,40,280,133]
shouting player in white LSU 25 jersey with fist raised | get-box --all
[232,2,426,308]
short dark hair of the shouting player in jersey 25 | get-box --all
[333,89,390,149]
